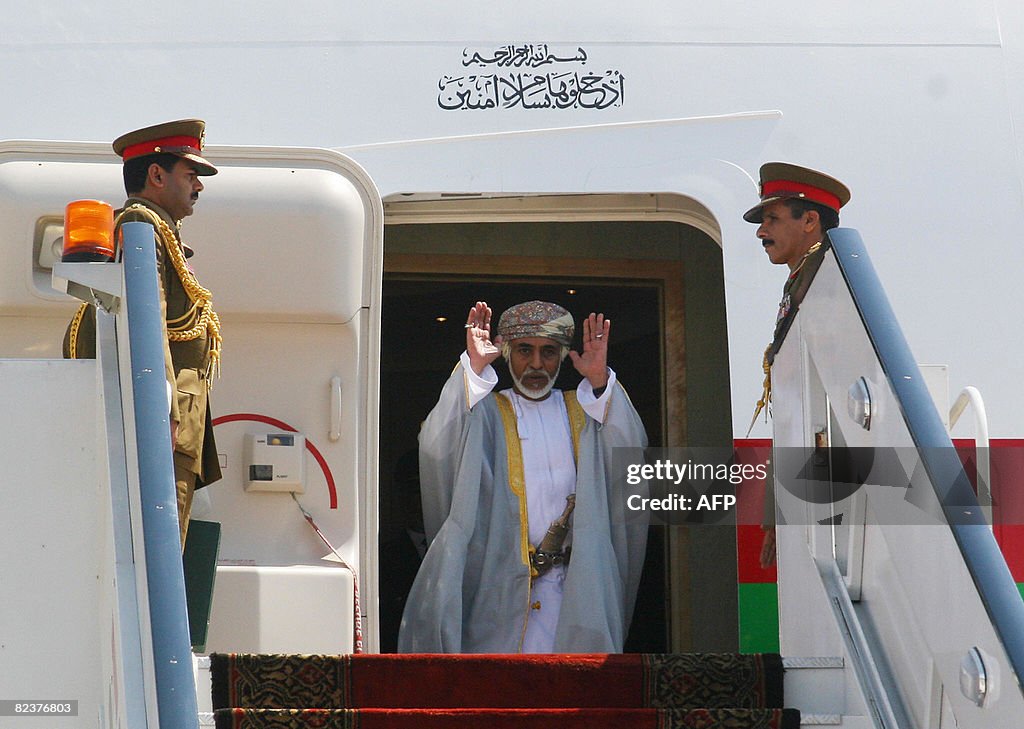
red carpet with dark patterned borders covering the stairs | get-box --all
[210,653,800,729]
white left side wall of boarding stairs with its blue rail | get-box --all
[0,222,199,729]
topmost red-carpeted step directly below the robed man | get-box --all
[211,653,782,710]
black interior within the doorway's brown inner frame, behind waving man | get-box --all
[380,274,669,652]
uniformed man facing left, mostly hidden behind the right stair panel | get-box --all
[743,162,850,567]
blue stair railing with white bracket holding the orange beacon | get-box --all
[53,222,199,729]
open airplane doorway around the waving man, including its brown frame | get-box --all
[379,208,738,652]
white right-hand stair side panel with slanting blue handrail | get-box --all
[772,228,1024,729]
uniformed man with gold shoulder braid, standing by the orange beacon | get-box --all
[63,119,221,548]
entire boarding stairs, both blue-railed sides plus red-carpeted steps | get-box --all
[0,223,1024,729]
